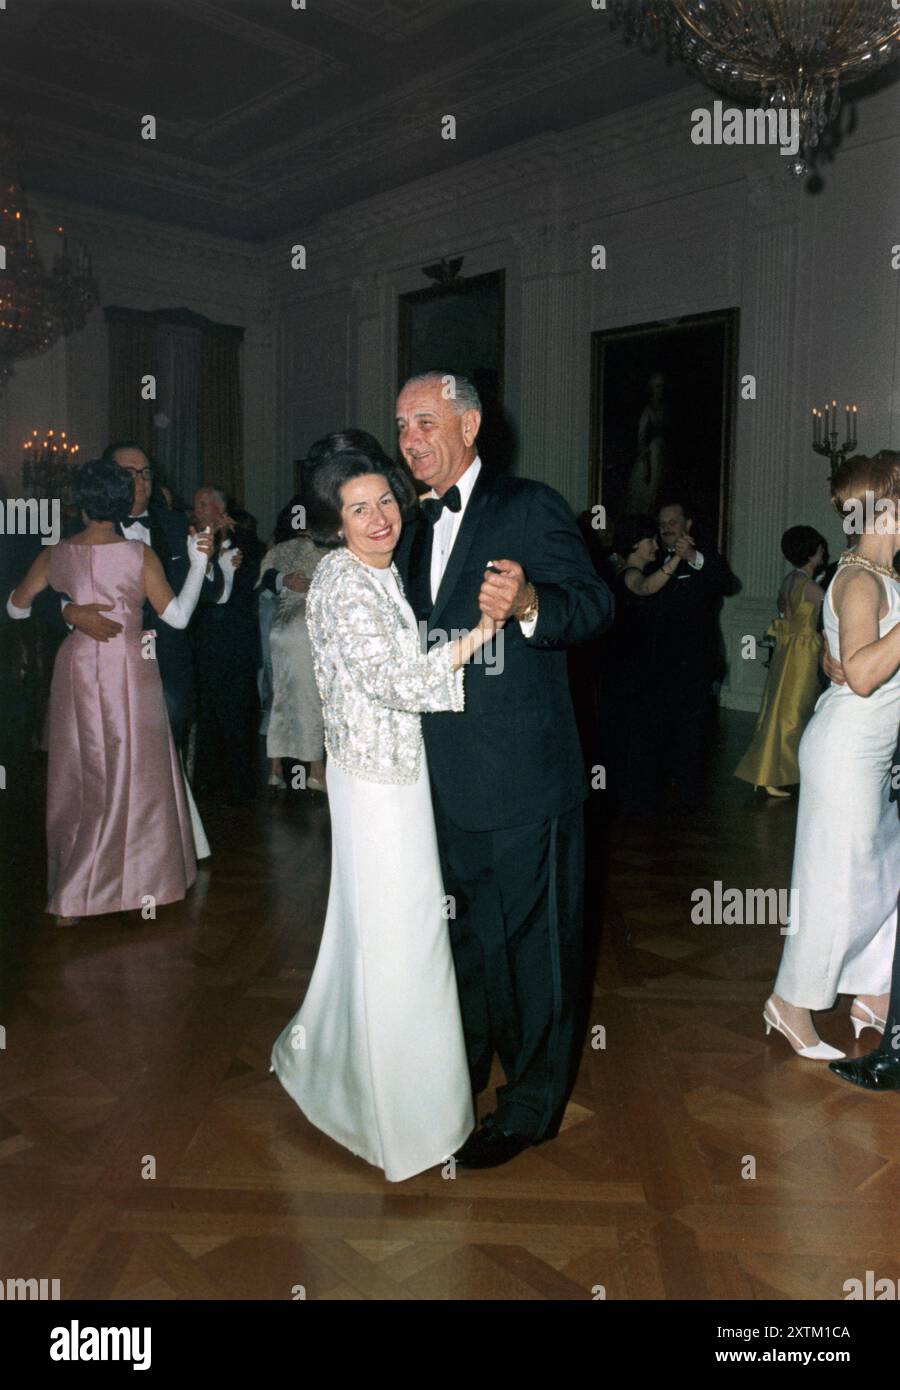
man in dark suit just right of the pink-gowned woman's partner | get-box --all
[192,485,264,806]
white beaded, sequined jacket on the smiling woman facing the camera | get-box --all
[306,548,463,784]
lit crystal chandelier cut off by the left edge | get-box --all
[0,131,97,391]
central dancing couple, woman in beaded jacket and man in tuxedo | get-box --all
[273,373,612,1182]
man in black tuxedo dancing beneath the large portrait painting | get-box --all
[654,502,737,812]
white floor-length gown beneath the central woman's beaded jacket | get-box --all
[273,567,474,1182]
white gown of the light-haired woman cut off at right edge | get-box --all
[775,571,900,1009]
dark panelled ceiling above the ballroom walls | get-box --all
[0,0,687,240]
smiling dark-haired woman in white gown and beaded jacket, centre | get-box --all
[271,450,495,1182]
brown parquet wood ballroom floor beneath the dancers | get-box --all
[0,714,900,1300]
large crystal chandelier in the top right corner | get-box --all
[608,0,900,178]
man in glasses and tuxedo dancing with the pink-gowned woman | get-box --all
[63,439,224,749]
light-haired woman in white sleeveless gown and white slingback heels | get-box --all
[764,455,900,1061]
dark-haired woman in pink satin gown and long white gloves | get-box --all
[7,456,213,926]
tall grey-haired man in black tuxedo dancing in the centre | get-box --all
[396,374,613,1168]
